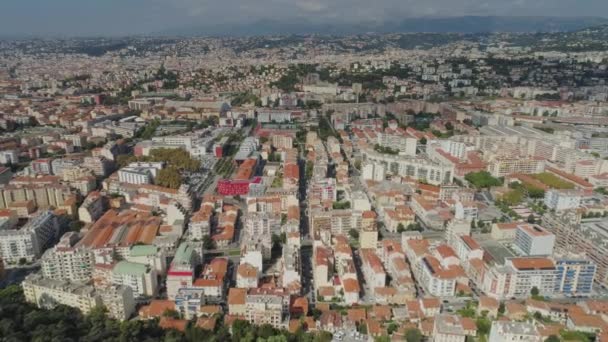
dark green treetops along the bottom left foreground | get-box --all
[0,285,331,342]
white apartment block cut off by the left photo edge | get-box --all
[0,211,59,263]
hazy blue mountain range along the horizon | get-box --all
[156,16,608,36]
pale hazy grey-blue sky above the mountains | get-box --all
[0,0,608,36]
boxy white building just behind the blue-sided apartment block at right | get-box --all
[514,224,555,256]
